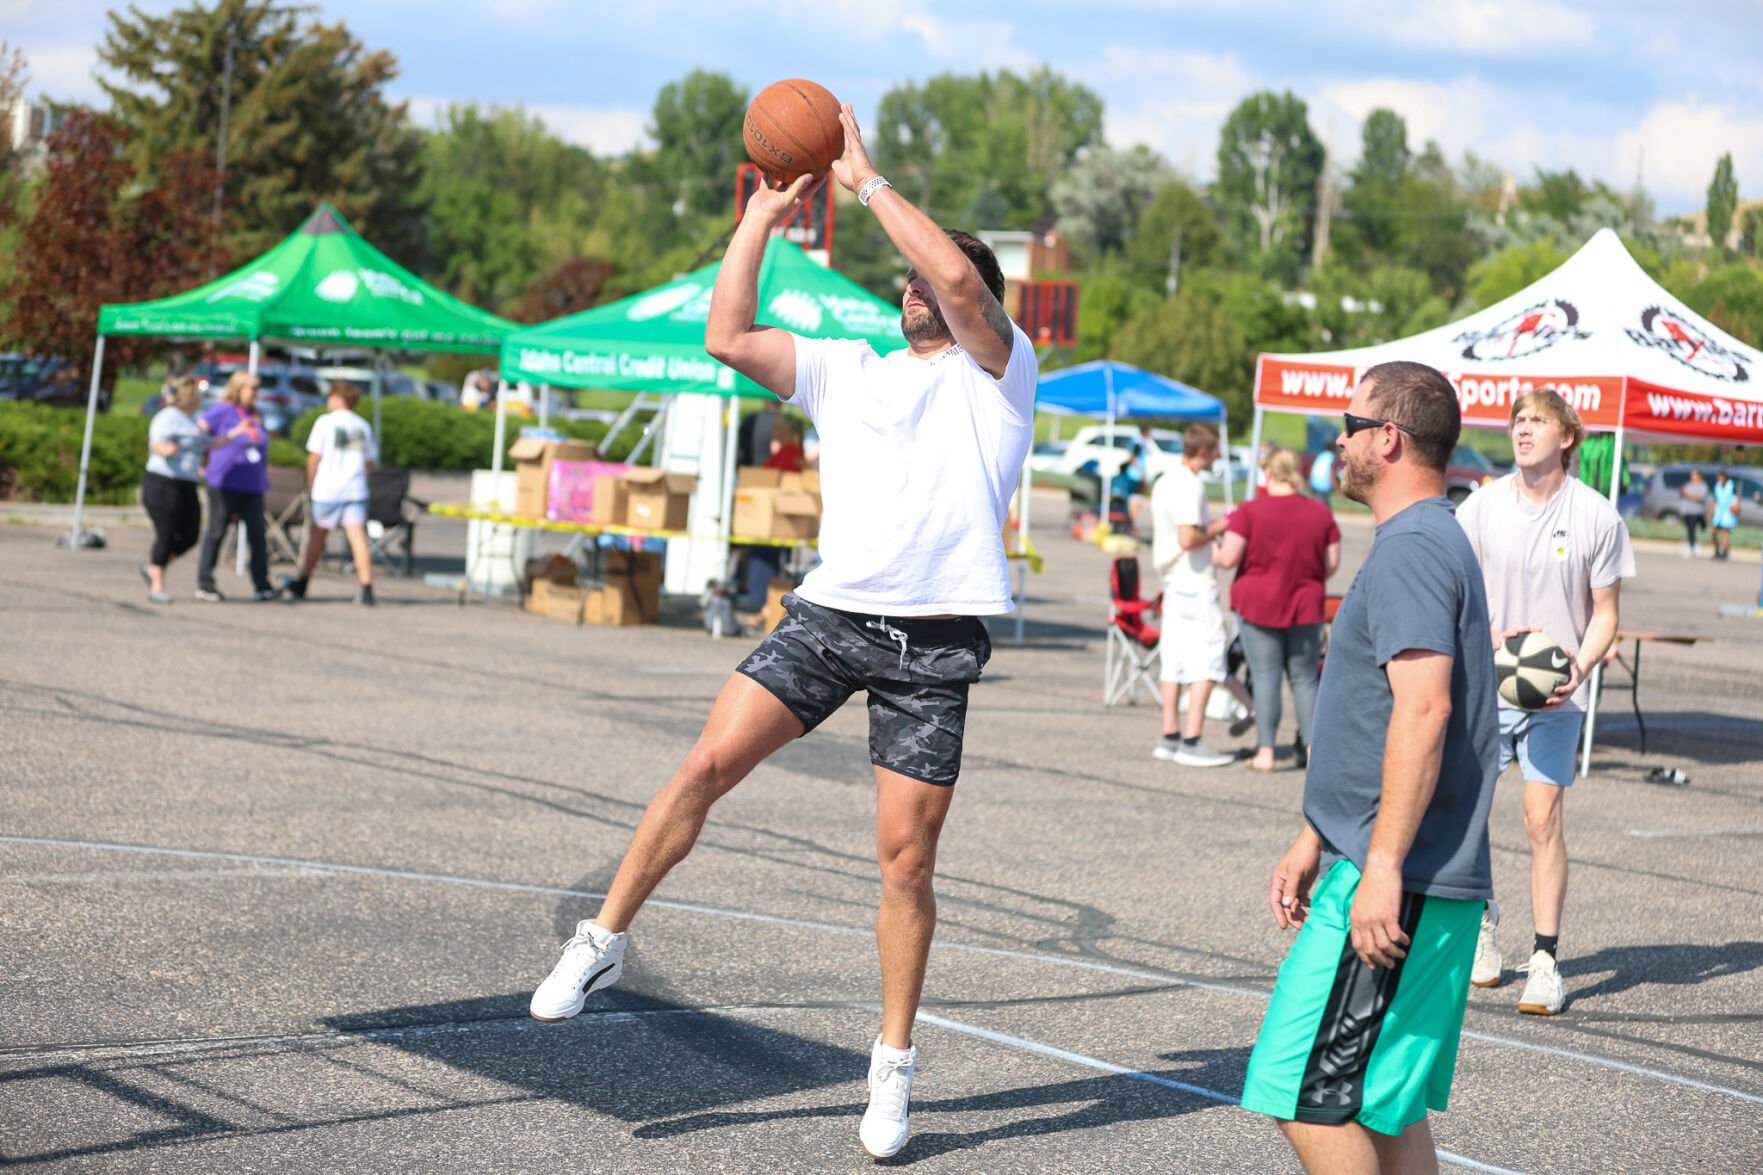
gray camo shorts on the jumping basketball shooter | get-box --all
[737,595,991,787]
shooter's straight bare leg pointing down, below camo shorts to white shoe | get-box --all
[876,767,956,1050]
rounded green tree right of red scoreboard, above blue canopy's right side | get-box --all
[1112,289,1255,427]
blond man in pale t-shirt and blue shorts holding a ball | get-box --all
[1456,388,1634,1016]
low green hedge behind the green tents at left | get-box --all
[0,399,642,506]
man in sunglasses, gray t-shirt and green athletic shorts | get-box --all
[1243,363,1499,1171]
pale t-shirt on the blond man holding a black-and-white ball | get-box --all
[1456,473,1634,709]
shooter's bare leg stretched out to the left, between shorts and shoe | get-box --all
[594,674,802,933]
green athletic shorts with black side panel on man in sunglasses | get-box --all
[1243,861,1486,1134]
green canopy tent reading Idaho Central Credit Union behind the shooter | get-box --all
[492,236,906,585]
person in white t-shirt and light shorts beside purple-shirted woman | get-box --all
[282,379,379,607]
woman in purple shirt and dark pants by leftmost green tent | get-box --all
[196,370,279,600]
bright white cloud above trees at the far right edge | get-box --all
[1615,99,1763,212]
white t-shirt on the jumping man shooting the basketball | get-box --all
[788,326,1038,616]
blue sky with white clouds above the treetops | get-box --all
[13,0,1763,213]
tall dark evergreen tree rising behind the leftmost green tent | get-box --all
[99,0,423,263]
